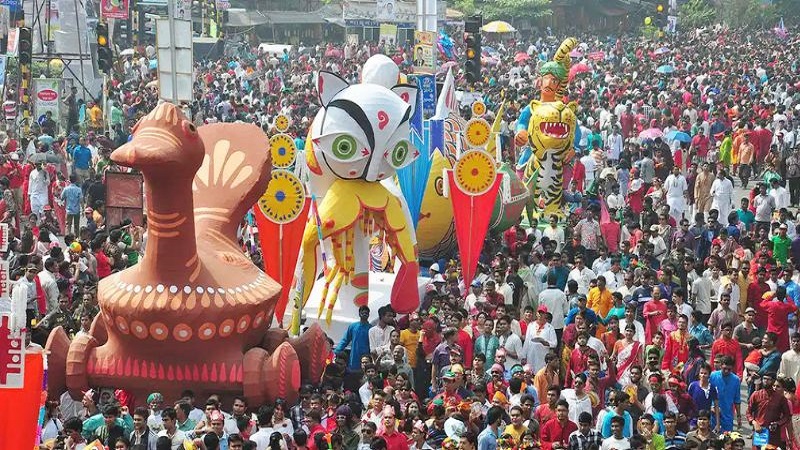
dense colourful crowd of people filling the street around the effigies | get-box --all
[0,8,800,450]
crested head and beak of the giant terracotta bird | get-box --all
[111,102,205,177]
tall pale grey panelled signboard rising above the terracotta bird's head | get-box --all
[156,18,194,103]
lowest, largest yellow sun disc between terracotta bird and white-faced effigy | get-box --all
[258,170,306,223]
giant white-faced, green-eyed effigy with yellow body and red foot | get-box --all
[293,55,419,324]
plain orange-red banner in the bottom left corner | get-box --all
[0,352,44,449]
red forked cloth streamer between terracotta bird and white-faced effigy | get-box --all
[253,198,316,326]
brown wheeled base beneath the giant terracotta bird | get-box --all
[46,324,330,404]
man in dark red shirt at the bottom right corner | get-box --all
[748,372,792,448]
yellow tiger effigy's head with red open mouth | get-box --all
[528,100,577,150]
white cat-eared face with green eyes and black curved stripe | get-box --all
[311,72,419,182]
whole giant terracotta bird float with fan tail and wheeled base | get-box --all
[46,103,330,404]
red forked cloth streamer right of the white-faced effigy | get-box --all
[447,171,503,285]
